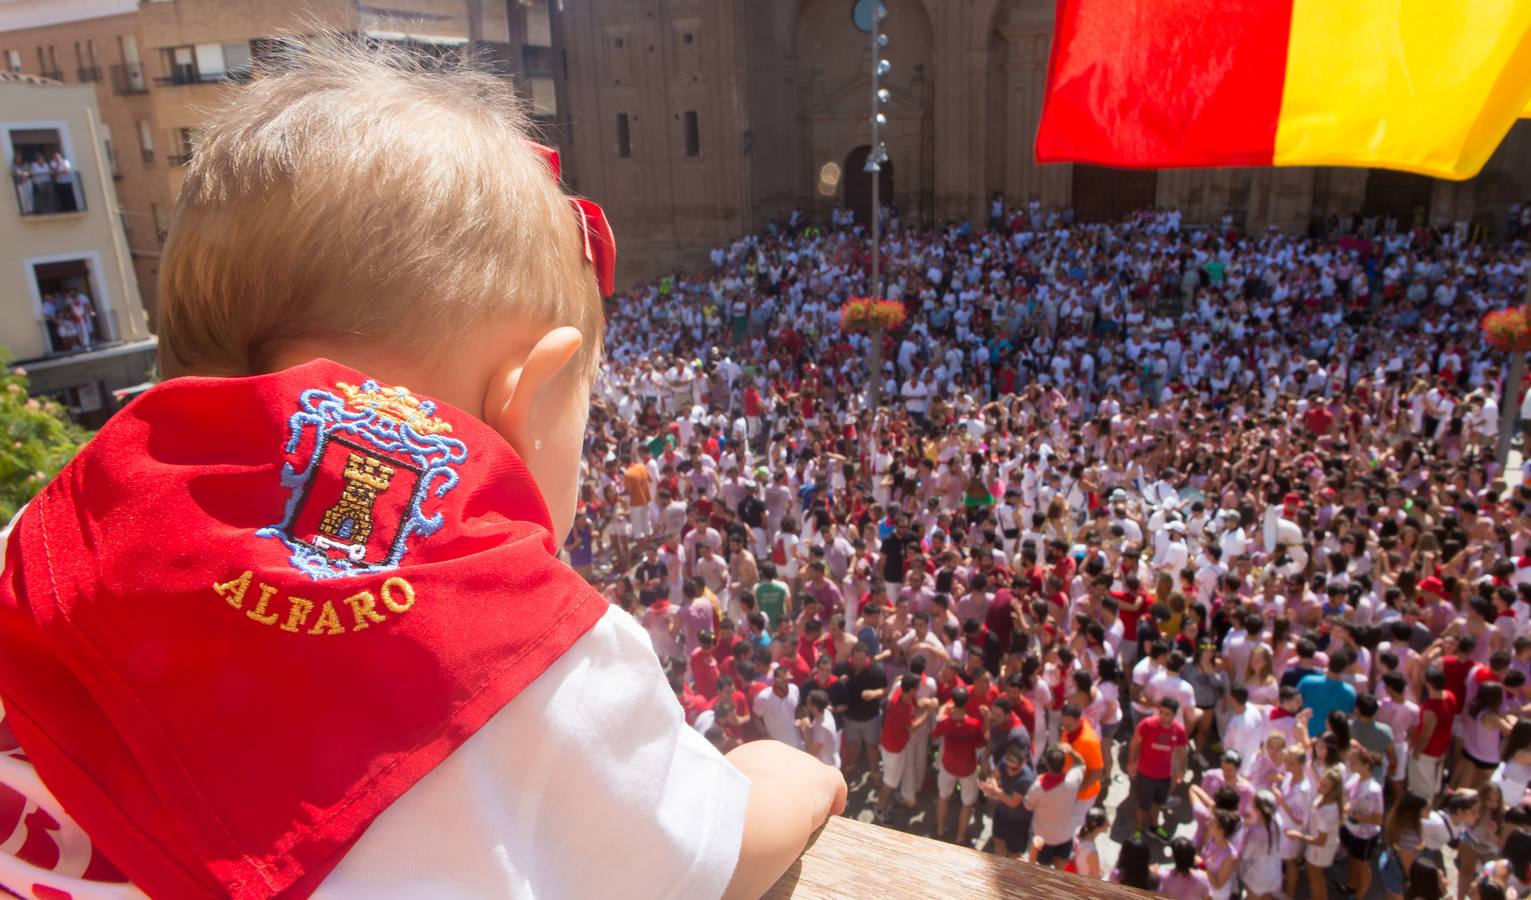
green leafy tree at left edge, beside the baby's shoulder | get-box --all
[0,349,90,525]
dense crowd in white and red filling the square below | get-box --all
[566,197,1531,900]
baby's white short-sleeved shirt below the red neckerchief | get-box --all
[326,608,750,897]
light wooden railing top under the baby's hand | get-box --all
[766,816,1150,900]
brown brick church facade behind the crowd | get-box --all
[550,0,1531,279]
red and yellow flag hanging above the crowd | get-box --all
[1036,0,1531,179]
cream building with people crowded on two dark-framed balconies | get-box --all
[0,72,155,426]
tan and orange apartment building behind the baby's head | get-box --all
[0,0,559,320]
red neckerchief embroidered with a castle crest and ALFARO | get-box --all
[0,360,606,897]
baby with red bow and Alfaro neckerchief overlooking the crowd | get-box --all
[0,38,845,897]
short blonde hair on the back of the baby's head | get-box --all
[159,34,602,380]
